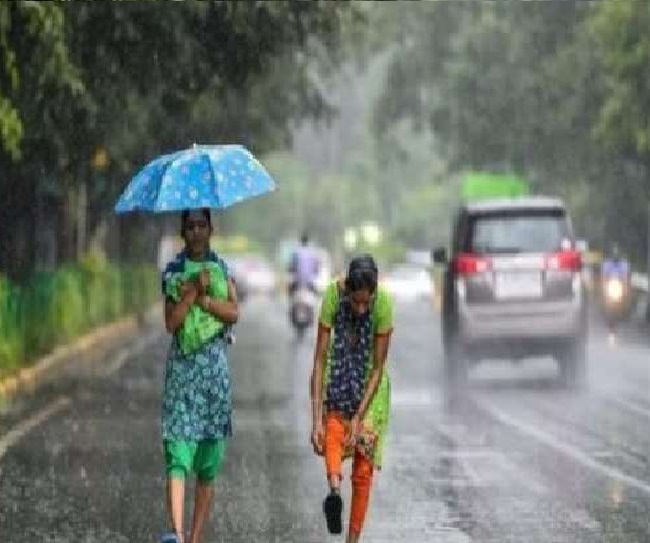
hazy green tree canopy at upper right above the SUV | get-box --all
[374,0,650,261]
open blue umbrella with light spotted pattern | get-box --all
[115,145,276,213]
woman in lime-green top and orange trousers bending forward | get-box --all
[311,255,393,543]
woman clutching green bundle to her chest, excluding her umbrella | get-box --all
[161,209,238,543]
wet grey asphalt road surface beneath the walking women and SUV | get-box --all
[0,300,650,543]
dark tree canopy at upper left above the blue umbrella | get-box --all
[0,1,357,278]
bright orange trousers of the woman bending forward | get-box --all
[325,413,374,534]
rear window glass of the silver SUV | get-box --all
[464,210,569,254]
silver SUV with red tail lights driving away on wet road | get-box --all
[434,197,587,386]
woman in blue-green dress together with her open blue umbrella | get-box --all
[115,145,276,543]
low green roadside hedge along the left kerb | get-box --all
[0,262,159,375]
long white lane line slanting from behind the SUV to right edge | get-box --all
[476,401,650,495]
